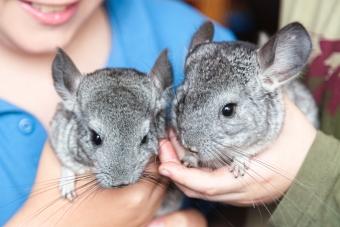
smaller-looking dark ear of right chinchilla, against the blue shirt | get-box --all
[189,21,214,52]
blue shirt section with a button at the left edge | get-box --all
[0,99,46,226]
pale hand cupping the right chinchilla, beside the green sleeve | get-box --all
[159,98,316,206]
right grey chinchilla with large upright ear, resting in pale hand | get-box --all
[172,22,318,177]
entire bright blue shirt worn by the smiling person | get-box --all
[0,0,234,223]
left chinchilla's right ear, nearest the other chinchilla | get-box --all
[149,49,172,92]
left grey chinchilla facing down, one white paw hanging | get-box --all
[50,49,182,213]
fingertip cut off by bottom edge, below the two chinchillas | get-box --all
[148,209,207,227]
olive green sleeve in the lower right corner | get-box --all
[269,131,340,227]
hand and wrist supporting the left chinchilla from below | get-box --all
[7,145,166,227]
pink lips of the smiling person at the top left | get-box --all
[20,0,79,26]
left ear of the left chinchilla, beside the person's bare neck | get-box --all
[52,48,81,108]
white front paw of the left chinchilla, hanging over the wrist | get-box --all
[59,167,77,201]
